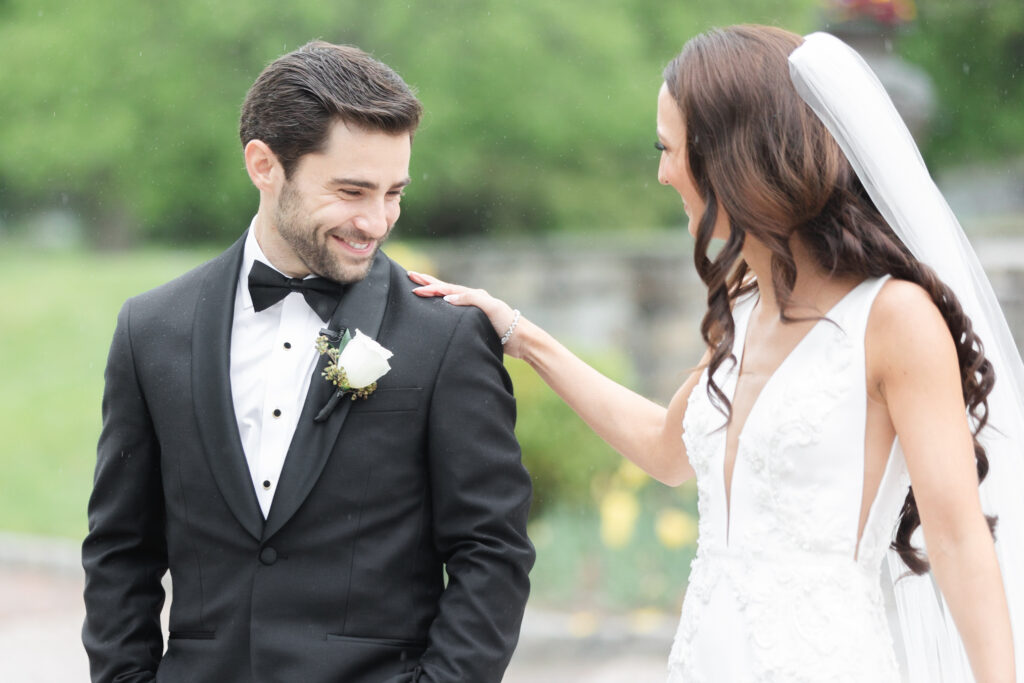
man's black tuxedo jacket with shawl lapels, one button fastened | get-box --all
[83,232,534,683]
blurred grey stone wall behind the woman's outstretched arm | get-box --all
[422,230,1024,402]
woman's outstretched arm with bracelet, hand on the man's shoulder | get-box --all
[410,273,700,486]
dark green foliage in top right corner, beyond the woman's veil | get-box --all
[899,0,1024,166]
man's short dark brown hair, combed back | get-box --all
[239,41,423,178]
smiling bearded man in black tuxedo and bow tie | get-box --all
[82,42,534,683]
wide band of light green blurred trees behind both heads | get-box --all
[0,0,818,244]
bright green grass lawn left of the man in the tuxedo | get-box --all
[0,243,212,539]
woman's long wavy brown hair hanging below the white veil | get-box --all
[665,26,995,573]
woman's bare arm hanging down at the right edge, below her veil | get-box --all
[867,281,1020,683]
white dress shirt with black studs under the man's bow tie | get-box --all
[231,225,325,518]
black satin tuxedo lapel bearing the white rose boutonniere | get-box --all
[262,253,391,541]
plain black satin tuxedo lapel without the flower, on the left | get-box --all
[191,233,263,540]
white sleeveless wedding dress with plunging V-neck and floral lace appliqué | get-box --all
[669,279,909,683]
